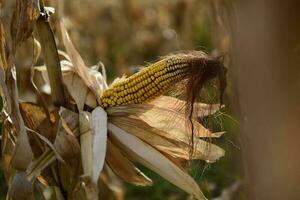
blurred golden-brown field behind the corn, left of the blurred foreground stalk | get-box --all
[0,0,245,200]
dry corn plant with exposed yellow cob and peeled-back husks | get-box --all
[0,0,226,199]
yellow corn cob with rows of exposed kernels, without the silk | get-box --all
[101,55,198,108]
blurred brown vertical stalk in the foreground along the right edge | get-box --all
[231,0,300,200]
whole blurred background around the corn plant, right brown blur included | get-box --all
[0,0,300,200]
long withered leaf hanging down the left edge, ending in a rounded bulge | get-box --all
[0,13,33,170]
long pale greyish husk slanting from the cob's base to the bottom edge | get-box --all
[108,123,206,200]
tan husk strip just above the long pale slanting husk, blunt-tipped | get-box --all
[110,116,224,162]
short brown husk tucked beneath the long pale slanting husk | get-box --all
[106,140,152,186]
